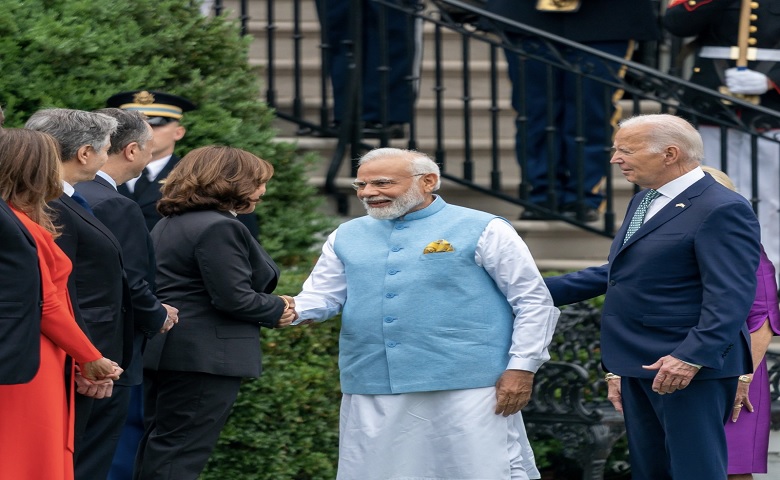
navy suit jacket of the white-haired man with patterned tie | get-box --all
[546,175,759,381]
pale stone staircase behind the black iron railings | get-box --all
[224,0,652,270]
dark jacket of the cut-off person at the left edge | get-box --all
[0,200,43,385]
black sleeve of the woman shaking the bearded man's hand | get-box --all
[195,221,284,327]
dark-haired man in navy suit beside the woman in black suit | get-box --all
[75,108,178,478]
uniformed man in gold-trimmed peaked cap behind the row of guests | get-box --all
[106,90,259,238]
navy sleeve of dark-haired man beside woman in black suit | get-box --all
[92,197,167,338]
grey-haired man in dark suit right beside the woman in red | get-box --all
[25,108,134,480]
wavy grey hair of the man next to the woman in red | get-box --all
[24,108,118,161]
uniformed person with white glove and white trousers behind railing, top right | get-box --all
[664,0,780,278]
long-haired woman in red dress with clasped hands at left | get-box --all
[0,129,121,480]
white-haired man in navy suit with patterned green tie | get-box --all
[547,115,759,480]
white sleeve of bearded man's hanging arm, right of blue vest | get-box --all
[475,219,560,373]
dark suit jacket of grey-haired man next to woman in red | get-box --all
[49,194,133,370]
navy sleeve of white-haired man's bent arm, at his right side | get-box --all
[671,201,760,369]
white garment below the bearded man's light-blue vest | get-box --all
[337,387,541,480]
